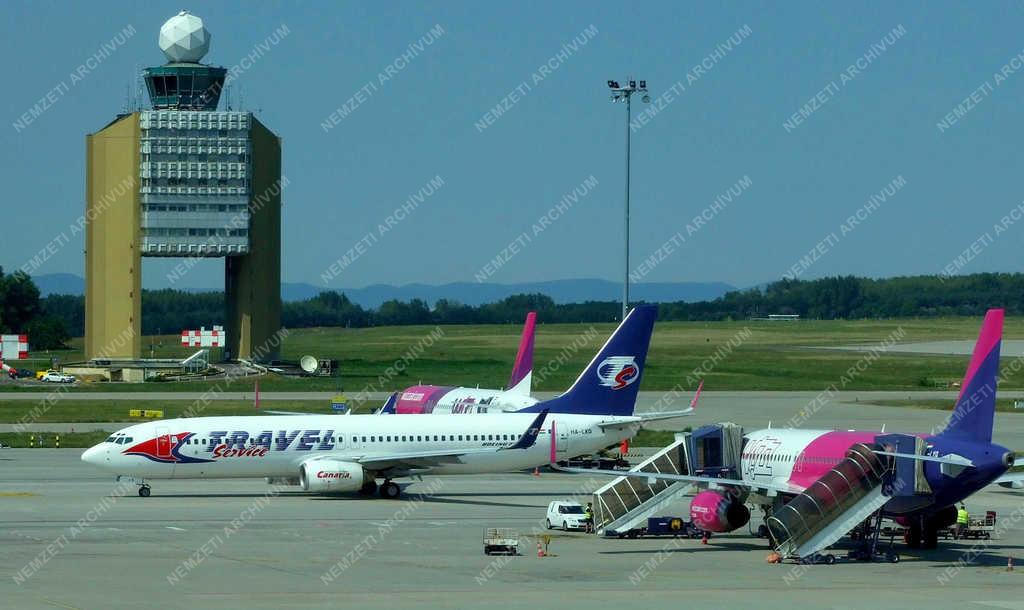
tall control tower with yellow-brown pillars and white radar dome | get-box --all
[85,11,282,360]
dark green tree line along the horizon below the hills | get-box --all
[19,273,1024,337]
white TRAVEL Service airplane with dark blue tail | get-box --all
[82,306,688,497]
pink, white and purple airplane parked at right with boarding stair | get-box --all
[559,309,1022,558]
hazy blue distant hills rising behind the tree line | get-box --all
[33,273,736,308]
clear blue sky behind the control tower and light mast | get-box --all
[0,2,1024,288]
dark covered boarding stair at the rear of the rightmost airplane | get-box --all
[767,434,931,563]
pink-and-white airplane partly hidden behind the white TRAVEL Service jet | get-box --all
[378,311,540,415]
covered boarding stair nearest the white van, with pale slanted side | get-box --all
[593,424,743,537]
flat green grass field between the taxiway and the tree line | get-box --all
[8,317,1024,393]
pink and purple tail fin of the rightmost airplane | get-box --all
[940,309,1005,442]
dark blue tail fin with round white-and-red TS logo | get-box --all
[519,305,657,416]
